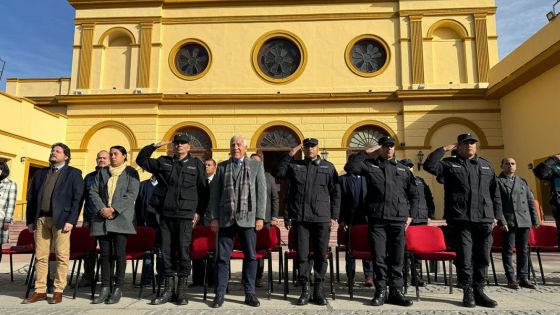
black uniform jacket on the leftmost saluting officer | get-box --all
[136,144,209,219]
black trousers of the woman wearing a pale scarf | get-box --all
[97,232,128,288]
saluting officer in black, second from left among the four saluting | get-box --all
[274,138,340,305]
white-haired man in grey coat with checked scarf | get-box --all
[209,135,266,308]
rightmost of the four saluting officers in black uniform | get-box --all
[424,133,502,307]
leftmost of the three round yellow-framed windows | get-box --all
[169,38,212,81]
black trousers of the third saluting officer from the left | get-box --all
[368,220,406,289]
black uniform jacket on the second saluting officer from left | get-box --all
[273,153,340,223]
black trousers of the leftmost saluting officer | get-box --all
[160,216,193,277]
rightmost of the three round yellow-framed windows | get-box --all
[344,34,390,78]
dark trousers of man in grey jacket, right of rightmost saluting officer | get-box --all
[502,226,530,280]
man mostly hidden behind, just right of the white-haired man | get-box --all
[251,153,280,288]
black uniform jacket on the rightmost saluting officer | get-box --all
[424,147,502,223]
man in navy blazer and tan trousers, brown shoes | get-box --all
[23,143,84,304]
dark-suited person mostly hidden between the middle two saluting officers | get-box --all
[338,169,373,287]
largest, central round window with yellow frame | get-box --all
[252,31,307,84]
